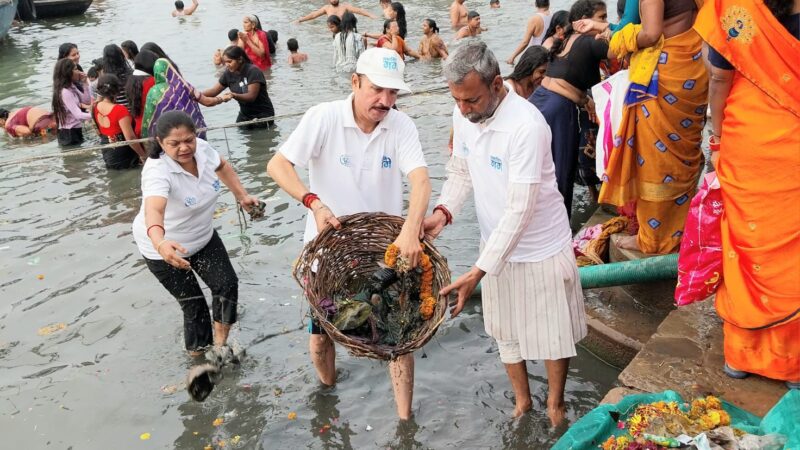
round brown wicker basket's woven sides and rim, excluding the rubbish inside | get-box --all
[293,213,450,360]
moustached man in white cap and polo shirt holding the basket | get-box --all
[267,48,431,419]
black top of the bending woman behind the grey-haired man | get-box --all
[546,34,608,91]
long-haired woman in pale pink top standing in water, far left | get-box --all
[52,58,92,146]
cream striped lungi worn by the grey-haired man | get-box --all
[481,244,587,360]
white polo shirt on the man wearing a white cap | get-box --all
[279,94,427,242]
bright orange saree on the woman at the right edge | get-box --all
[695,0,800,381]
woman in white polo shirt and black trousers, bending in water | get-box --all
[133,111,258,356]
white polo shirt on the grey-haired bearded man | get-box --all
[453,86,572,262]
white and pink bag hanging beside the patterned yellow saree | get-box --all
[592,70,631,180]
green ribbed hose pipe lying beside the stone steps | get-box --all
[466,253,678,295]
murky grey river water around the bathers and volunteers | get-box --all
[0,0,617,449]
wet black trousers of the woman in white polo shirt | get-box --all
[145,230,239,351]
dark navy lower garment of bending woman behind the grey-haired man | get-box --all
[528,86,580,217]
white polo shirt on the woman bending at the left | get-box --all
[133,138,221,259]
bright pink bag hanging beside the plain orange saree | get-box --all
[675,172,724,306]
